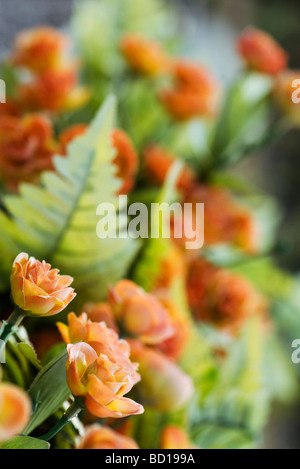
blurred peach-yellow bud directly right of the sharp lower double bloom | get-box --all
[128,340,194,412]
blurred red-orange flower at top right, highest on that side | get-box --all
[237,28,288,75]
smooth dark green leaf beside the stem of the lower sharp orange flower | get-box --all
[24,350,71,435]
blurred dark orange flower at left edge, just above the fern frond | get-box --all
[0,114,55,191]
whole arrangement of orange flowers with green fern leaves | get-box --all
[0,0,300,450]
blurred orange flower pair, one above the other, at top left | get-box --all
[11,27,88,113]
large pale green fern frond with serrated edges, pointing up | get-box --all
[0,98,138,301]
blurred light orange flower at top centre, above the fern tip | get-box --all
[120,34,170,76]
